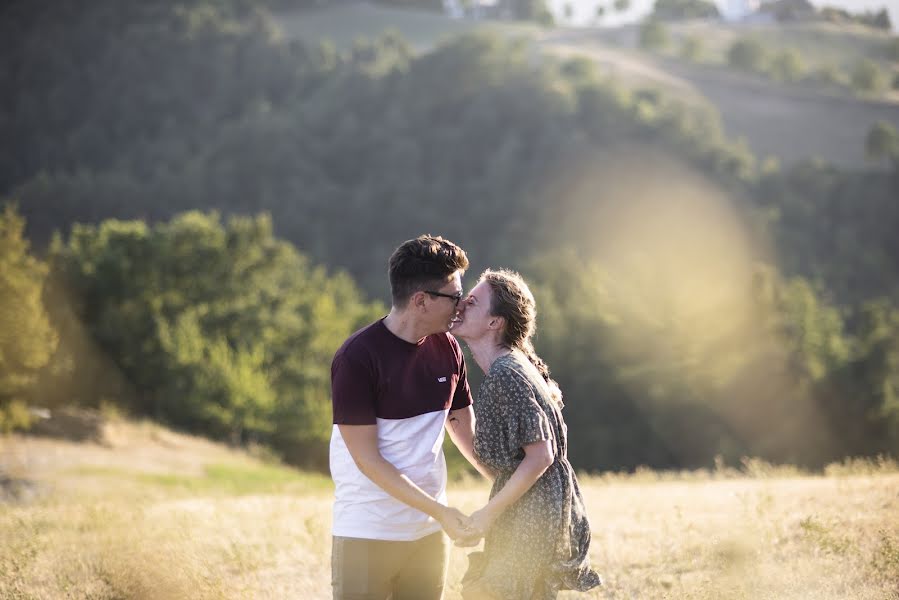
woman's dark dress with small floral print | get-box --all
[462,352,601,600]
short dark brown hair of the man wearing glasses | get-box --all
[388,235,468,308]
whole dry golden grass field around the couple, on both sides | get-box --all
[0,423,899,600]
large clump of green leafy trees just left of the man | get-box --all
[52,212,383,468]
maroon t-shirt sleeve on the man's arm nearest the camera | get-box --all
[331,348,378,425]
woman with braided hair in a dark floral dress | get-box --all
[453,270,601,600]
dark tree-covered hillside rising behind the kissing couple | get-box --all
[0,0,899,468]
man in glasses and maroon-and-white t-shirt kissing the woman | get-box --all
[330,235,488,600]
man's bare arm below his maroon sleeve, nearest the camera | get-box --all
[337,425,470,539]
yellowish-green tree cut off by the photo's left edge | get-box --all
[0,204,57,432]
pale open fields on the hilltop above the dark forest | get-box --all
[277,3,899,168]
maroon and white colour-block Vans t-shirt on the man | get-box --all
[331,320,471,541]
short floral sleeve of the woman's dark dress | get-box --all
[495,372,553,450]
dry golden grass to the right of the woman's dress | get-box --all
[572,474,899,600]
